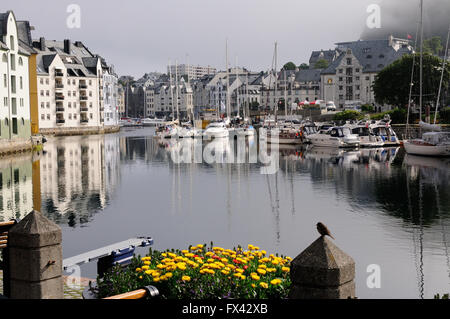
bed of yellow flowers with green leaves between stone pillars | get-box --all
[96,243,292,299]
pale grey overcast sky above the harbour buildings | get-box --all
[0,0,450,77]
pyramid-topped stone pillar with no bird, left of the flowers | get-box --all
[8,211,64,299]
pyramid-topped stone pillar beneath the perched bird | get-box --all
[289,237,355,299]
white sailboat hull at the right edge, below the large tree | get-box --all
[403,132,450,156]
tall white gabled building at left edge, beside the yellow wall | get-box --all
[0,11,34,143]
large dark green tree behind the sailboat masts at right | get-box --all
[373,54,450,107]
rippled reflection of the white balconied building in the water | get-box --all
[40,135,120,227]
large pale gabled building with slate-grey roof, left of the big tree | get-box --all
[320,36,414,111]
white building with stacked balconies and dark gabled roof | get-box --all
[33,38,107,131]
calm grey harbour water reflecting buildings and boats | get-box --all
[0,129,450,298]
